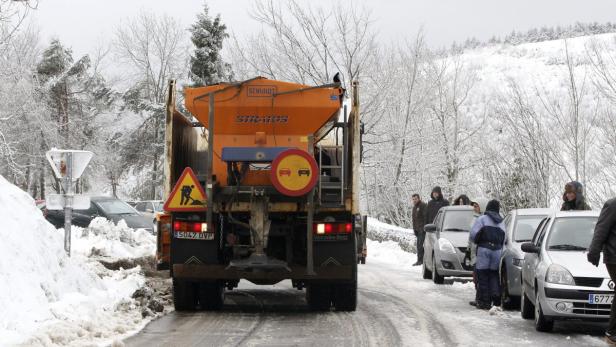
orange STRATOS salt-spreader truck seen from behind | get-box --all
[156,77,365,311]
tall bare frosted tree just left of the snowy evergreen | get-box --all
[115,12,188,199]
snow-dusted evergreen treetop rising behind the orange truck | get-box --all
[190,5,231,86]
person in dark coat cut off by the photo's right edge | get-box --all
[586,198,616,345]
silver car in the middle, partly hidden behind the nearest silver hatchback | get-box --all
[499,208,553,309]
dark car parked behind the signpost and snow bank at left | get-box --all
[45,196,153,233]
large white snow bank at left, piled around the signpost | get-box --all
[0,176,153,346]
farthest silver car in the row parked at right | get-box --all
[422,206,475,284]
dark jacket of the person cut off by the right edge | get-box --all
[588,198,616,264]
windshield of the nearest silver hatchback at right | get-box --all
[548,217,597,251]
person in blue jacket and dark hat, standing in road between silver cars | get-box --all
[470,200,505,310]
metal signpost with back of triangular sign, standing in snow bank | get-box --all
[46,148,93,257]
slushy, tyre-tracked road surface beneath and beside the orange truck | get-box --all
[124,241,605,347]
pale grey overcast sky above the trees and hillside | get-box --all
[32,0,616,55]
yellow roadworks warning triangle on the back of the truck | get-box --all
[163,167,207,212]
